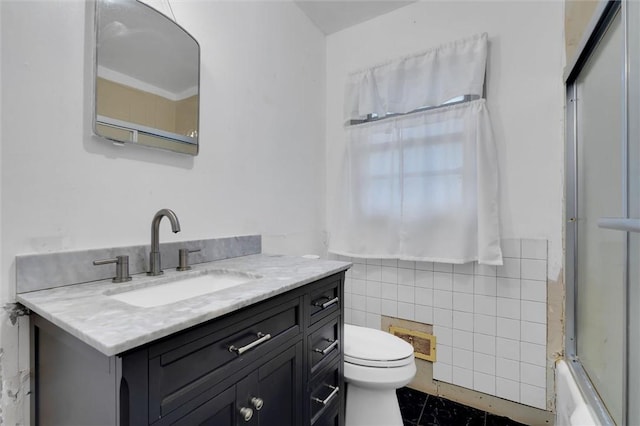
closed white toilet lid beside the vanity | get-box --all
[343,324,413,367]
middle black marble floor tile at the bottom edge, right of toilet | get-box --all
[418,396,486,426]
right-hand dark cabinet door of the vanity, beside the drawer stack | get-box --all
[237,342,303,426]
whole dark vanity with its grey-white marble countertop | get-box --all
[18,254,349,426]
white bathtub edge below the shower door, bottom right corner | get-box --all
[556,360,602,426]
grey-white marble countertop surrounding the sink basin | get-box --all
[16,254,351,356]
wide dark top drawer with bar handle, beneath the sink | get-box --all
[149,298,302,422]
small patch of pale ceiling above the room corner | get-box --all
[294,0,416,34]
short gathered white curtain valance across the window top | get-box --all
[344,33,487,121]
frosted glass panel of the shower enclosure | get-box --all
[575,9,626,424]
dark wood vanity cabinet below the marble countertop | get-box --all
[32,273,345,426]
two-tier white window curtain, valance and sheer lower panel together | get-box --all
[329,34,502,265]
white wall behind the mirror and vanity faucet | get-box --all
[0,0,325,424]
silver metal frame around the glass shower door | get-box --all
[564,0,629,426]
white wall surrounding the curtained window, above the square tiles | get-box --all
[326,0,564,280]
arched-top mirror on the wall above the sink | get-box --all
[94,0,200,155]
